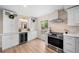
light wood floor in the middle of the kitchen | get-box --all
[3,39,55,53]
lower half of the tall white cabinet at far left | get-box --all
[2,34,19,50]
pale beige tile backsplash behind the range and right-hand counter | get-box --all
[50,23,79,33]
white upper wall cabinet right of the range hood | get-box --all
[67,6,79,26]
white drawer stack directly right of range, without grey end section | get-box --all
[63,36,75,53]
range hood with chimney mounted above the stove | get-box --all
[50,9,67,23]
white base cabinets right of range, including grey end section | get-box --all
[63,35,79,53]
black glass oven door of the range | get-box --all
[48,36,63,49]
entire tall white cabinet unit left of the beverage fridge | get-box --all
[2,10,19,50]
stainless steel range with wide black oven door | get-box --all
[48,32,63,52]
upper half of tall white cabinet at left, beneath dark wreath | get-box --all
[3,10,18,33]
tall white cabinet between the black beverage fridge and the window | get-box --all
[28,17,38,41]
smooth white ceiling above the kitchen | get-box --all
[0,5,73,17]
